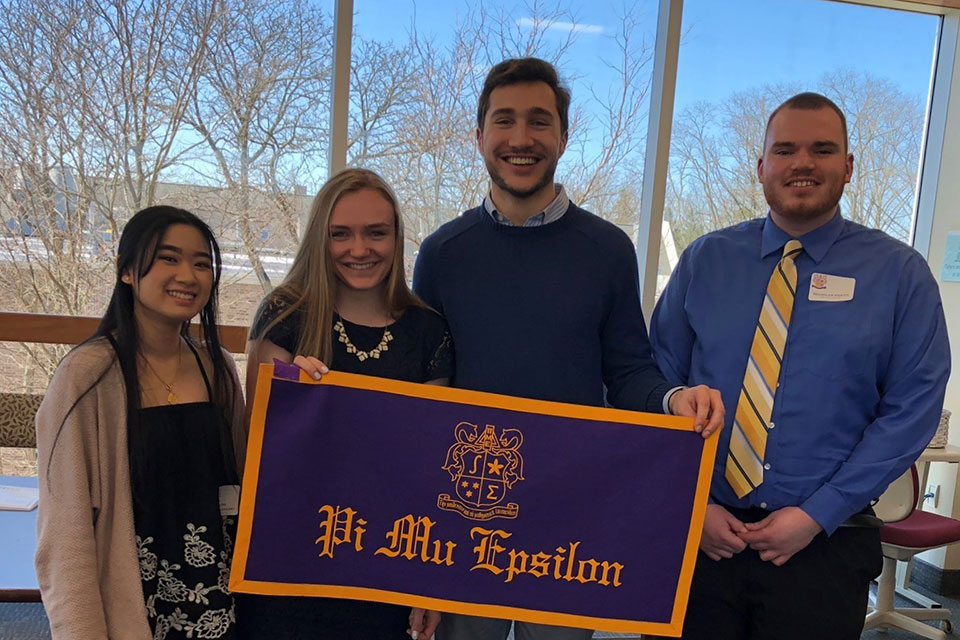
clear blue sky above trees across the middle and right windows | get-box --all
[354,0,939,122]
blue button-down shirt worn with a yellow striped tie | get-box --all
[650,212,950,533]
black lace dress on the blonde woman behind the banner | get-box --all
[238,297,453,640]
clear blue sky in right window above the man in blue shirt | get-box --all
[677,0,939,105]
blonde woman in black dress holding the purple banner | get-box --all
[238,169,453,640]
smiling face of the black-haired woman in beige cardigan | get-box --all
[120,224,213,325]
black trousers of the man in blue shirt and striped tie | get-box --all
[683,509,883,640]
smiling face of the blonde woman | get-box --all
[327,189,397,290]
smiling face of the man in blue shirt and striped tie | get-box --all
[757,108,853,235]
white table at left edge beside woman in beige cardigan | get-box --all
[0,476,40,602]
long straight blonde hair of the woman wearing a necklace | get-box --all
[250,168,426,364]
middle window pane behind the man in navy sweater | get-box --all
[347,0,656,272]
